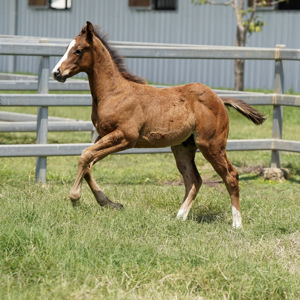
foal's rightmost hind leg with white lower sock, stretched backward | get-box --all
[199,145,242,228]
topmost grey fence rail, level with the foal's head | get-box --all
[0,39,300,60]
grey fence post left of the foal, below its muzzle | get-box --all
[35,56,49,183]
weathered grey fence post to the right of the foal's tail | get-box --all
[271,45,286,168]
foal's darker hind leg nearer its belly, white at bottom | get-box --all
[171,139,202,220]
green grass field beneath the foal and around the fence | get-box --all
[0,98,300,299]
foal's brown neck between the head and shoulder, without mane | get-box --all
[88,46,126,102]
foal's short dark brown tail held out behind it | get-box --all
[221,97,267,125]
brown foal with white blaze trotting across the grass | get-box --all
[53,22,265,228]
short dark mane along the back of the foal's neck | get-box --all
[94,26,146,84]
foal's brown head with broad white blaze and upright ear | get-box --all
[52,22,94,82]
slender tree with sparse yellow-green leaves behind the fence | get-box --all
[191,0,288,91]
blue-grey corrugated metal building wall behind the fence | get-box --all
[0,0,300,91]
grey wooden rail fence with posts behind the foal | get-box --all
[0,36,300,182]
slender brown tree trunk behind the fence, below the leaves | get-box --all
[234,26,246,91]
